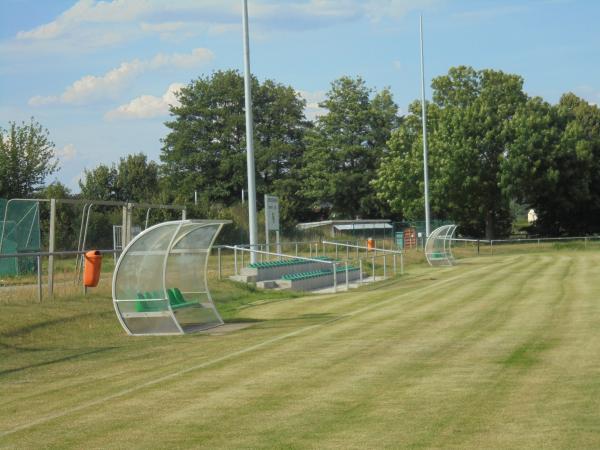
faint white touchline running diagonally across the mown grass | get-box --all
[0,258,515,437]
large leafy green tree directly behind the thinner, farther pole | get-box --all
[374,66,527,238]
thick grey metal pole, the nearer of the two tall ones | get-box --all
[242,0,258,263]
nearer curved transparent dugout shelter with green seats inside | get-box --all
[112,220,231,335]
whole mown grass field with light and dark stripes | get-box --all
[0,250,600,449]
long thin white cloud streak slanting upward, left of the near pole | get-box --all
[29,48,214,106]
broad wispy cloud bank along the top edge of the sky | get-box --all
[7,0,438,51]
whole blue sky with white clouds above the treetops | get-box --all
[0,0,600,192]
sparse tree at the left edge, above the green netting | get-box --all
[0,118,58,198]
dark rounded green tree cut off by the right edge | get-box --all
[502,94,600,235]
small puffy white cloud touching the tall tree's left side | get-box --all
[105,83,184,120]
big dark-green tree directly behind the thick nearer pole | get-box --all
[160,70,308,224]
